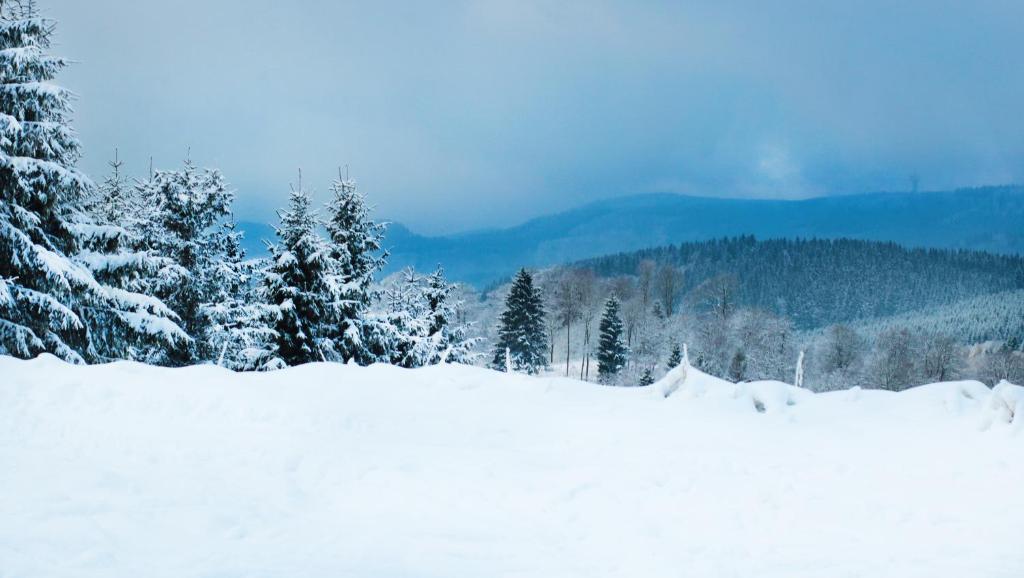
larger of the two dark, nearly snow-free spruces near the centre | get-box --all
[490,269,548,373]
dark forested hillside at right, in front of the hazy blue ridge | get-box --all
[573,237,1024,328]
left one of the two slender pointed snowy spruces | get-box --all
[262,184,341,366]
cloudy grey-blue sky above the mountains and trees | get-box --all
[49,0,1024,233]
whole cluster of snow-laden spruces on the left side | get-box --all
[0,2,474,370]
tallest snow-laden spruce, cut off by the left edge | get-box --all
[0,2,186,363]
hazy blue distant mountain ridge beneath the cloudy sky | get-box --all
[237,187,1024,285]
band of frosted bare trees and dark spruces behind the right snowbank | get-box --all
[481,260,1024,390]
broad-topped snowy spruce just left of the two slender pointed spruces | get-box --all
[137,160,234,365]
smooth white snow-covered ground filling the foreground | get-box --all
[0,358,1024,578]
